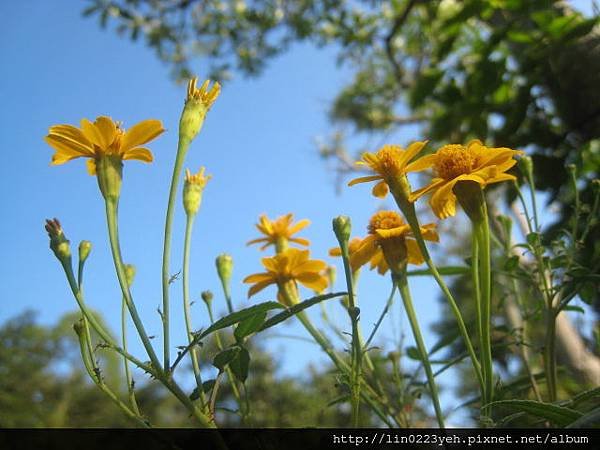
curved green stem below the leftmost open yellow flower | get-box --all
[106,199,163,373]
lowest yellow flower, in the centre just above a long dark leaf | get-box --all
[244,248,329,306]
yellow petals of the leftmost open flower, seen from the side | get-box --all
[44,116,165,175]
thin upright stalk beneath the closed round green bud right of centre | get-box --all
[340,239,363,428]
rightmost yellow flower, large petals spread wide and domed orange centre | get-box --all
[407,140,523,219]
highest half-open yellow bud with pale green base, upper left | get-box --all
[179,77,221,143]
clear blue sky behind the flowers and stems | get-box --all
[0,0,589,426]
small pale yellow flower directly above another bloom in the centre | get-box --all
[246,213,310,253]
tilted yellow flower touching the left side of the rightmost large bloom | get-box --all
[348,141,427,198]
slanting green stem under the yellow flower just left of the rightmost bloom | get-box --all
[392,197,484,390]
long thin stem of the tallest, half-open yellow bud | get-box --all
[162,138,190,371]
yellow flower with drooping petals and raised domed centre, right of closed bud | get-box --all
[350,211,439,275]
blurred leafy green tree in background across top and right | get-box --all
[83,0,600,418]
